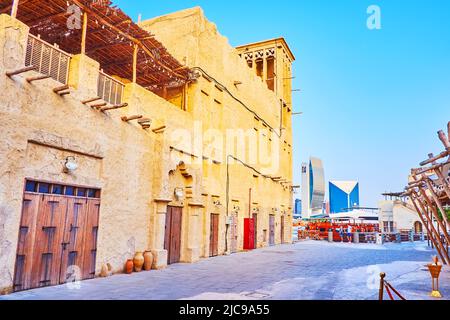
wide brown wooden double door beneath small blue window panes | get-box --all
[14,182,100,291]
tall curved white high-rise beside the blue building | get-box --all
[302,158,325,219]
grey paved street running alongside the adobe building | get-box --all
[0,241,450,300]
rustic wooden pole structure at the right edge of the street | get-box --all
[400,122,450,264]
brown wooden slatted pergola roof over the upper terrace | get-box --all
[0,0,192,91]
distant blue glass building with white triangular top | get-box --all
[329,181,359,213]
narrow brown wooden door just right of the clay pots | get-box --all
[164,207,183,264]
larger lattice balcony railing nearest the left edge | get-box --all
[25,34,71,84]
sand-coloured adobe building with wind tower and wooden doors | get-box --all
[0,0,294,293]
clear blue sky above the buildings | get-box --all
[114,0,450,206]
